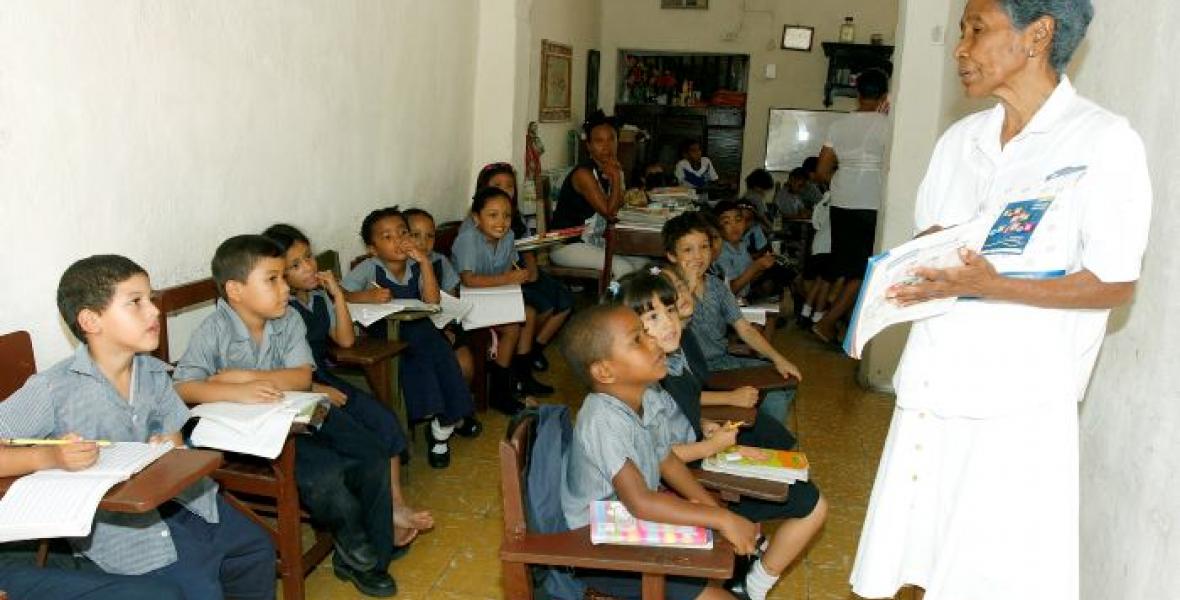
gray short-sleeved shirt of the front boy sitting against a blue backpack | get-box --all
[562,385,694,529]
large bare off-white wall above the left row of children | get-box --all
[0,0,477,367]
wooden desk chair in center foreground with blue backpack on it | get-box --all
[500,417,734,600]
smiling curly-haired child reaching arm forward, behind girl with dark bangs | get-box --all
[663,213,801,423]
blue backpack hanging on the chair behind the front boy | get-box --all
[509,404,585,600]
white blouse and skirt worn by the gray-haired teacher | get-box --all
[852,77,1152,600]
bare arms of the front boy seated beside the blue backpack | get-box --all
[611,454,758,554]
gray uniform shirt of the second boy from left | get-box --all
[172,299,315,383]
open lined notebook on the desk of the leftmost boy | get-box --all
[0,442,172,543]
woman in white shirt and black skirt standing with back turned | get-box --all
[812,69,890,341]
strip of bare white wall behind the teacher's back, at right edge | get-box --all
[1074,0,1180,600]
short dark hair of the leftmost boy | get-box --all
[58,254,148,341]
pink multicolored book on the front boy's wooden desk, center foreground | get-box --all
[590,500,713,549]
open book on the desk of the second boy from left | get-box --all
[190,392,328,458]
